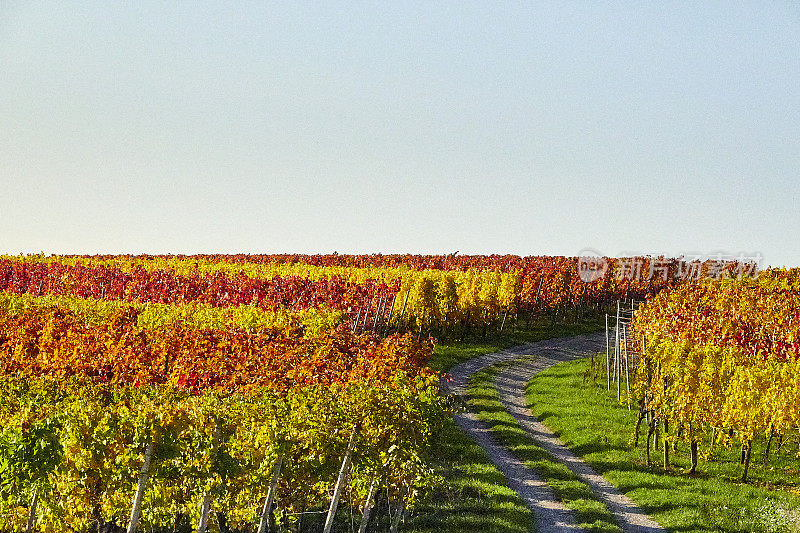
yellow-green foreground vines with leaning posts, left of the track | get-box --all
[0,375,449,532]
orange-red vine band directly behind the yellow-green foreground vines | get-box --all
[0,307,430,391]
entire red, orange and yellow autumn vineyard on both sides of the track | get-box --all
[0,254,764,533]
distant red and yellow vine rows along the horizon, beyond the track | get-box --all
[0,256,752,330]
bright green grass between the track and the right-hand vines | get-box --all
[527,359,800,533]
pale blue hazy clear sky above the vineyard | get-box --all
[0,0,800,266]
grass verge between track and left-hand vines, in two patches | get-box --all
[403,319,601,533]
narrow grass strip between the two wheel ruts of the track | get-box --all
[469,363,620,532]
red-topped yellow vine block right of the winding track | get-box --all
[632,269,800,481]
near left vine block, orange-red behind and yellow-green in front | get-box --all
[0,298,448,531]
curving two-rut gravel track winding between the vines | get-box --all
[449,334,664,533]
